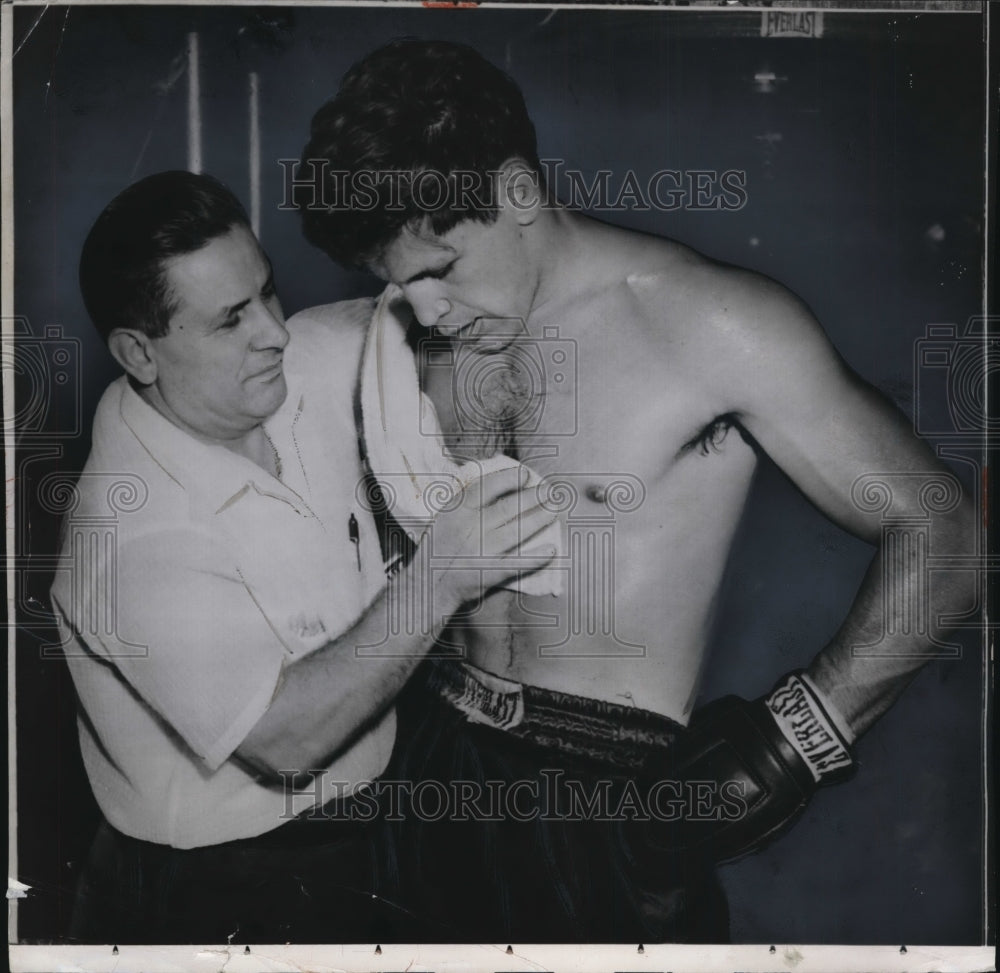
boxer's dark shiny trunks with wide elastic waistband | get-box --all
[393,660,728,943]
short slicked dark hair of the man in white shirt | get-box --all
[80,171,250,341]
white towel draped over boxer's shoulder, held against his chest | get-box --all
[361,284,563,595]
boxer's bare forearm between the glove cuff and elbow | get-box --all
[807,504,978,736]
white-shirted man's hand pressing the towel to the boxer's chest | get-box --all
[422,466,556,603]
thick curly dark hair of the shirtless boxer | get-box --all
[293,38,541,267]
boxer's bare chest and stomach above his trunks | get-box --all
[420,280,755,716]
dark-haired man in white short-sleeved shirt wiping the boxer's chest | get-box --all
[52,172,552,942]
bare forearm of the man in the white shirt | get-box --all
[237,552,460,774]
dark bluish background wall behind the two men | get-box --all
[14,4,984,943]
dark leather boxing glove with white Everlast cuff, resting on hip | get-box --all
[647,673,854,862]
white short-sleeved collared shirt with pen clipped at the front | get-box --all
[52,301,395,848]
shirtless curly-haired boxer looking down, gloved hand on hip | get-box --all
[296,40,972,941]
